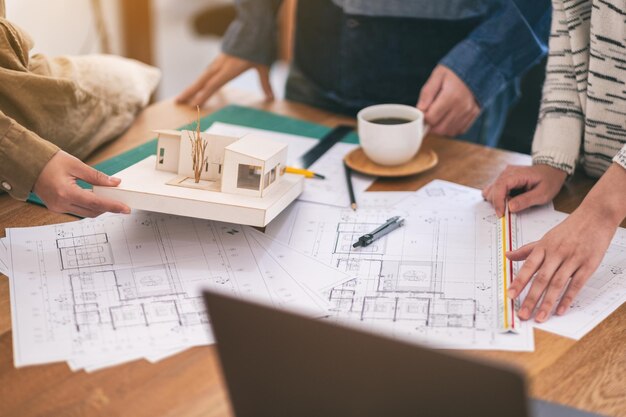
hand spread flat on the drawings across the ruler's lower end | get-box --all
[507,206,619,323]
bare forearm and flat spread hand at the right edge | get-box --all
[507,160,626,323]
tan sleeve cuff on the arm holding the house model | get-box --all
[0,110,59,200]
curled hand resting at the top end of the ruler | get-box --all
[483,165,567,217]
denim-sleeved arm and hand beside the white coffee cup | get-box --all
[417,0,550,136]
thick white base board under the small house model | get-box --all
[94,155,304,227]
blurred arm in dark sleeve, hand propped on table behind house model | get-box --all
[176,0,282,106]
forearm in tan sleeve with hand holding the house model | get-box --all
[0,111,130,217]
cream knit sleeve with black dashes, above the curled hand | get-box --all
[532,0,583,175]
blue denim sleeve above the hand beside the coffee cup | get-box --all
[440,0,552,108]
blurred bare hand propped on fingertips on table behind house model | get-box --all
[176,53,274,106]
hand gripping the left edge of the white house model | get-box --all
[33,151,130,217]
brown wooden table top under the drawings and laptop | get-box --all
[0,91,626,417]
